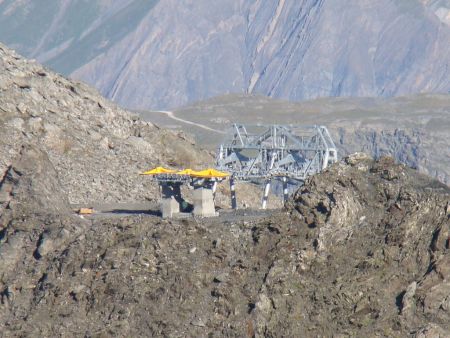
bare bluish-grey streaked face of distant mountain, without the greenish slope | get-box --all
[73,0,450,108]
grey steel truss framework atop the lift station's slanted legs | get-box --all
[216,124,337,181]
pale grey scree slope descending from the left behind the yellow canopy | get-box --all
[0,45,211,203]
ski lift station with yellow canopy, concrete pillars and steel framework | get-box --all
[142,124,337,218]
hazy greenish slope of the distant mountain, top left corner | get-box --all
[0,0,158,75]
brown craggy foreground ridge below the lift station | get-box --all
[0,154,450,338]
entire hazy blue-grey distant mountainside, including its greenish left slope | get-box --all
[0,0,450,109]
